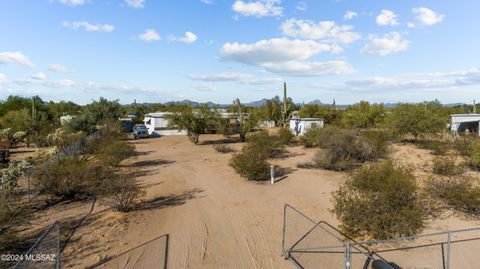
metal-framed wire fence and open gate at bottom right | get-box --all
[282,204,480,269]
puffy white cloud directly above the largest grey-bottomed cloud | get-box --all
[281,19,361,43]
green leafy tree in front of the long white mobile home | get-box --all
[167,105,220,144]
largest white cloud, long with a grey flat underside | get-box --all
[220,38,342,66]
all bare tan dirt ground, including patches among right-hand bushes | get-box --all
[17,135,480,269]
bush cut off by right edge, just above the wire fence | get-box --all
[426,177,480,216]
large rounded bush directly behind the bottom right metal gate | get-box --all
[333,161,424,239]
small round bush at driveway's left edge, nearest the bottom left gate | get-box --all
[101,175,144,212]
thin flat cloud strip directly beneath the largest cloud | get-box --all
[264,61,355,76]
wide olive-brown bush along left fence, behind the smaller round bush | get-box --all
[34,156,110,200]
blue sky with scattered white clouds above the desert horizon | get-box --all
[0,0,480,104]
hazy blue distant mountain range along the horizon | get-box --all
[139,98,464,108]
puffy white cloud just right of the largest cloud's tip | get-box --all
[361,32,409,56]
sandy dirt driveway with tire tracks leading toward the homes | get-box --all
[117,136,342,269]
